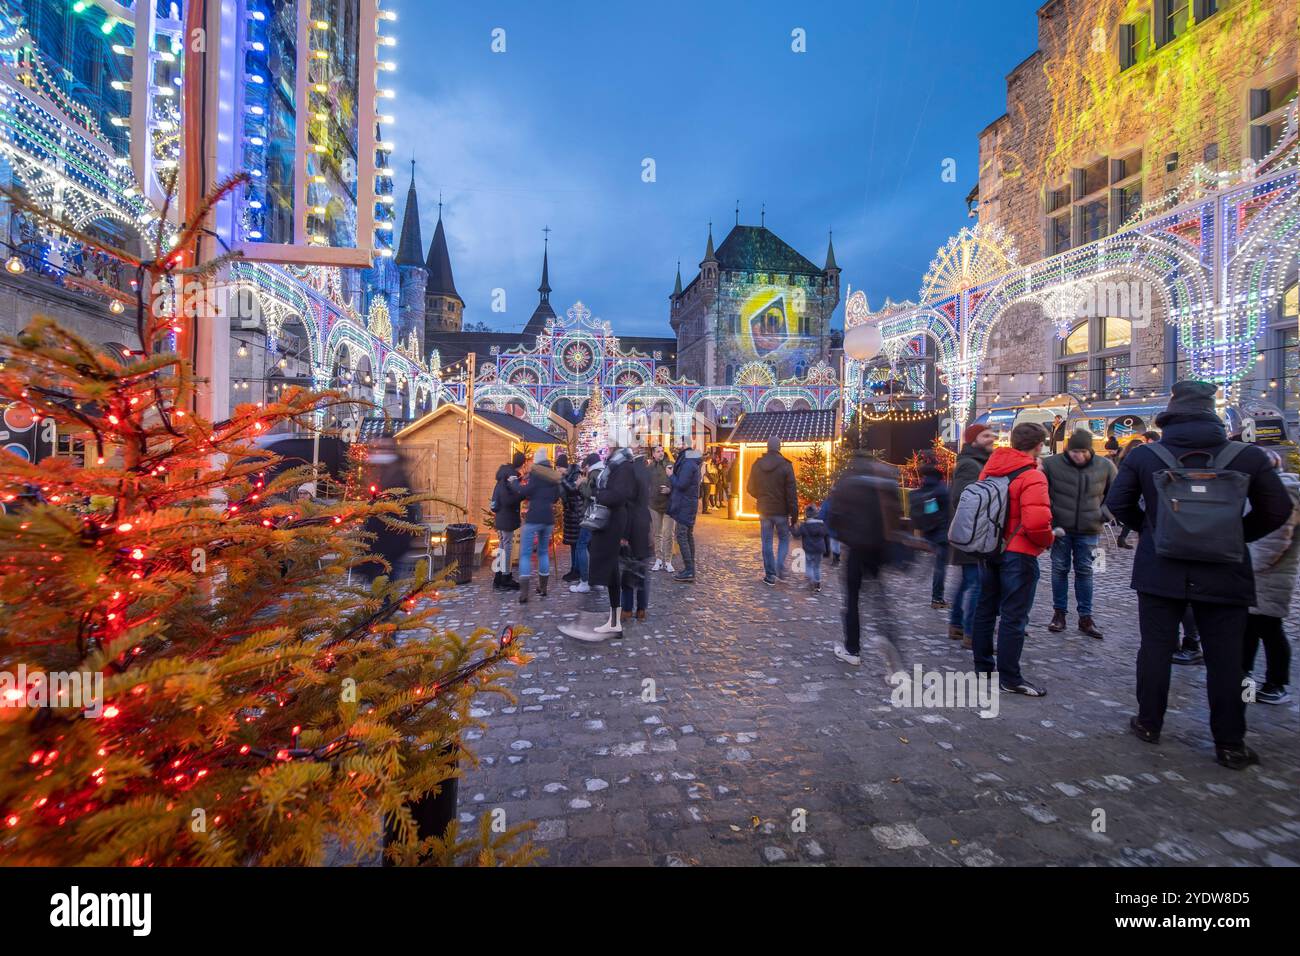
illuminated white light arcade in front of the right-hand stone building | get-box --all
[845,115,1300,427]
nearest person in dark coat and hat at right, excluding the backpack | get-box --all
[1106,381,1291,770]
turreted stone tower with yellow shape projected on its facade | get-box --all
[670,224,840,386]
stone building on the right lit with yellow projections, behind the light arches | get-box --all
[976,0,1300,415]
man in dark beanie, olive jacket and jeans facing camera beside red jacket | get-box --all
[1043,428,1115,640]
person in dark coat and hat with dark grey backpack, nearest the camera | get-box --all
[1106,381,1292,770]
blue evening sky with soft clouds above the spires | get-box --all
[385,0,1041,336]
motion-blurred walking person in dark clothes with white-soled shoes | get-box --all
[827,449,902,672]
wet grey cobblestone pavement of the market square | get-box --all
[434,516,1300,866]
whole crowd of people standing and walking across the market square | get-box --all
[493,381,1300,769]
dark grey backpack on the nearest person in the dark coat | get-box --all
[1147,441,1251,564]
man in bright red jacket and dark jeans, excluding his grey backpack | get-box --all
[971,421,1052,697]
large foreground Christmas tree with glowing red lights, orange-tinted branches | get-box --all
[0,178,534,866]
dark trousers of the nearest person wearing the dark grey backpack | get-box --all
[1138,592,1247,747]
